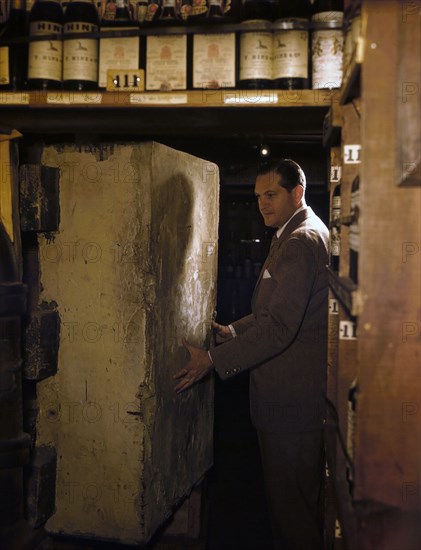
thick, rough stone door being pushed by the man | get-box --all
[29,142,219,544]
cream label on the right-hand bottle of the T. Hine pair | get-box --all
[273,31,308,78]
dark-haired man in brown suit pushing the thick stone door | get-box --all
[174,159,328,550]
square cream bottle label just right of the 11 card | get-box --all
[146,34,187,91]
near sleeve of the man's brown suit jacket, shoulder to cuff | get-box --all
[211,238,318,379]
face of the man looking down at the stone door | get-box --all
[254,172,299,227]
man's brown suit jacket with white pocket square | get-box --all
[211,207,329,433]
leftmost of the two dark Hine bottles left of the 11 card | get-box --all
[28,0,63,90]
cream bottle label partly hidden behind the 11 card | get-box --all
[98,27,139,88]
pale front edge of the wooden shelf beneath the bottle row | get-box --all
[0,89,339,109]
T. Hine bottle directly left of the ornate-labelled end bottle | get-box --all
[273,0,310,90]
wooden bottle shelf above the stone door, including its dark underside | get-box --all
[0,89,339,140]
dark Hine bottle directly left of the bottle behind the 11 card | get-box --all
[63,0,99,90]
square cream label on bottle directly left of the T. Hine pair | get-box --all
[193,33,235,88]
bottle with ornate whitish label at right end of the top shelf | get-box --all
[312,0,344,89]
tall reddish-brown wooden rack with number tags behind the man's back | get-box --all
[323,0,421,550]
